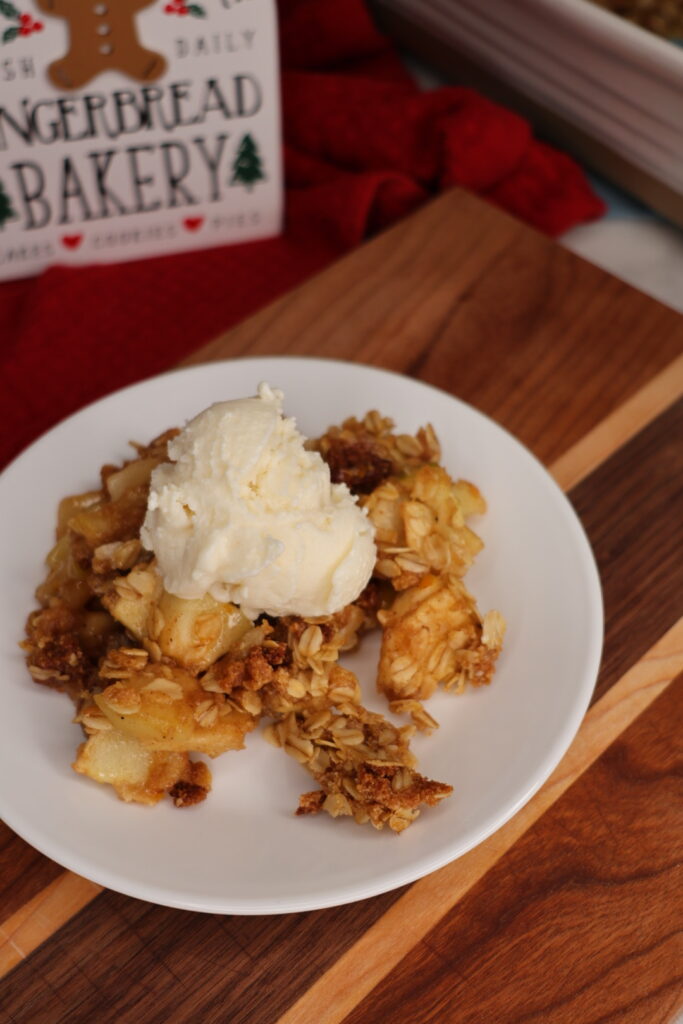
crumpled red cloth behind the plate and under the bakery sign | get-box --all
[0,0,603,464]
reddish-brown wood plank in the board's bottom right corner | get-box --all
[344,677,683,1024]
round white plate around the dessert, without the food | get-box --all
[0,357,602,913]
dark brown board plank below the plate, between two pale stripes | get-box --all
[0,890,402,1024]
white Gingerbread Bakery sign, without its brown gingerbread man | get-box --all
[0,0,283,280]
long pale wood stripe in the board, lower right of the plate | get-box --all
[278,620,683,1024]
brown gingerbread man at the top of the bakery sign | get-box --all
[36,0,166,89]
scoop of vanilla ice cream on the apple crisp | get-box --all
[140,384,376,617]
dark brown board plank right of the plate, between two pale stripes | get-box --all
[569,399,683,699]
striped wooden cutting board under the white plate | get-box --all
[0,190,683,1024]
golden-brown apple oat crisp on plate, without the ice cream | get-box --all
[23,412,505,833]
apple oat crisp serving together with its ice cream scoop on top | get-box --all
[24,385,504,831]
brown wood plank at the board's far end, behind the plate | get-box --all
[187,190,683,463]
